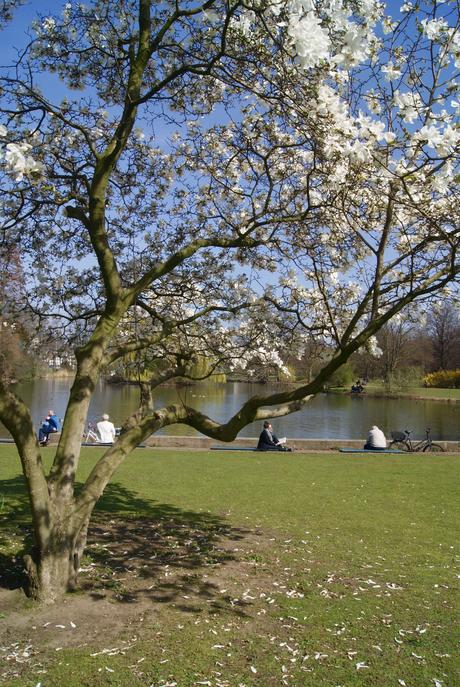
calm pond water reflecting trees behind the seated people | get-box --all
[0,379,460,441]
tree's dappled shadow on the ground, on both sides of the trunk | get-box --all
[0,475,254,615]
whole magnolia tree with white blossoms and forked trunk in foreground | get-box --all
[0,0,460,601]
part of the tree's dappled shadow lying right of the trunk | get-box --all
[83,484,252,614]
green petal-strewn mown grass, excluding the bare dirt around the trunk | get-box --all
[0,447,460,687]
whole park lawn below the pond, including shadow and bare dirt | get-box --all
[0,446,460,687]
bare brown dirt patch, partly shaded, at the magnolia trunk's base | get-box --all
[0,513,269,682]
